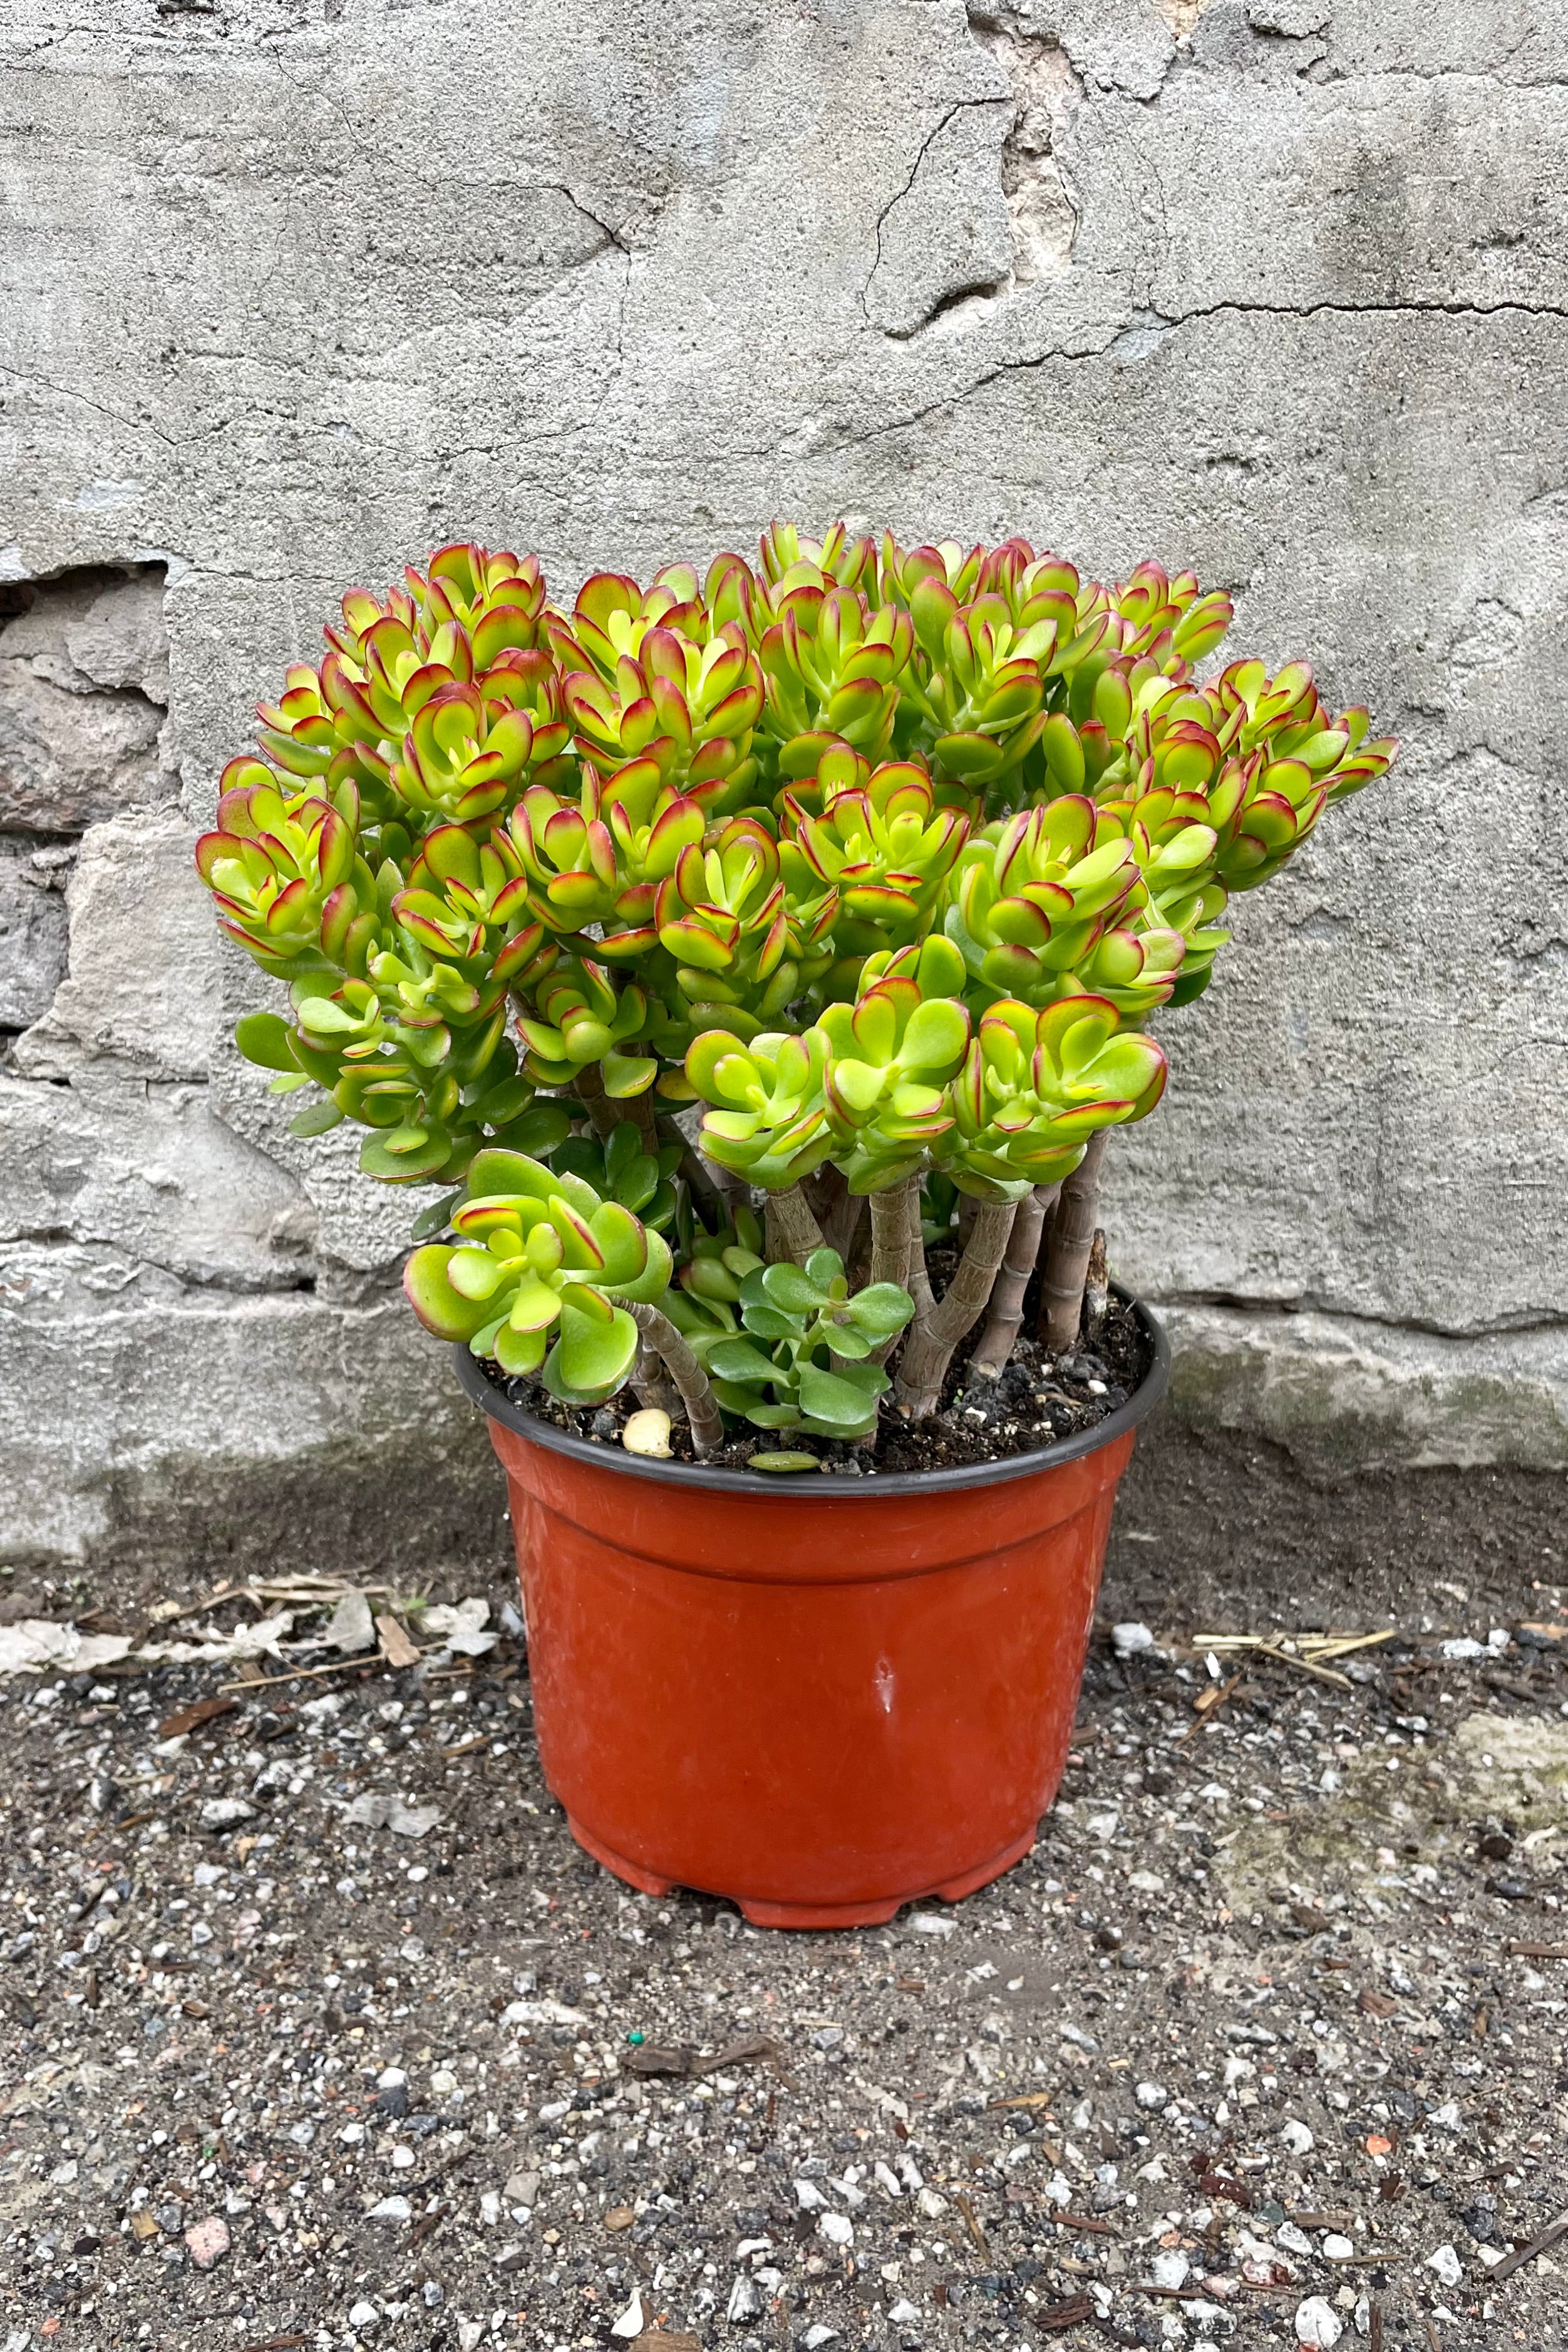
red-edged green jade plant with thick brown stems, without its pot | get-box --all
[197,525,1396,1458]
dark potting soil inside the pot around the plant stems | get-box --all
[484,1251,1152,1477]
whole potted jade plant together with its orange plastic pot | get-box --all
[197,525,1394,1926]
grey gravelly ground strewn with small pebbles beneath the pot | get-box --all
[0,1587,1568,2352]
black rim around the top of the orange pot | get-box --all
[451,1282,1171,1503]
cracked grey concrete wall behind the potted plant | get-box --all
[0,0,1568,1564]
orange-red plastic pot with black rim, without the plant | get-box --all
[456,1308,1171,1926]
